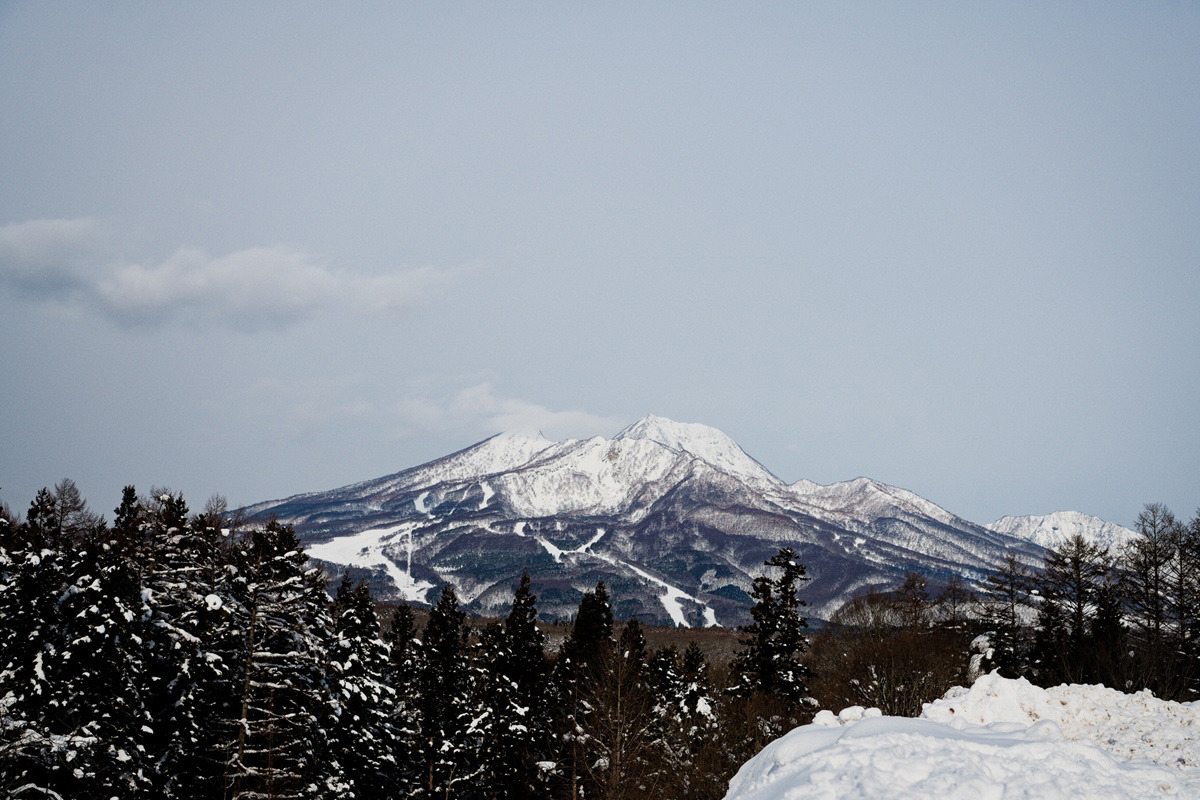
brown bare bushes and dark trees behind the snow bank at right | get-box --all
[809,504,1200,716]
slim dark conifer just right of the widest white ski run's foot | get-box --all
[414,583,479,798]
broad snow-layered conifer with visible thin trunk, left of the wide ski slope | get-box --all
[226,521,337,800]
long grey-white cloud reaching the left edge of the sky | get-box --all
[0,219,462,329]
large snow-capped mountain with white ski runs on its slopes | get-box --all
[245,416,1043,625]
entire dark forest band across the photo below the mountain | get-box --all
[0,480,1200,800]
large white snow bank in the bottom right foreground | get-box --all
[725,673,1200,800]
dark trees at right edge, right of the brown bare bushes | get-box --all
[978,504,1200,700]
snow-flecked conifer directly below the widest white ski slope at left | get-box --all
[329,572,398,800]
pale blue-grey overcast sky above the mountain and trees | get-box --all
[0,2,1200,532]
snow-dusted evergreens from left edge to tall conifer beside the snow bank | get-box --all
[0,480,814,800]
